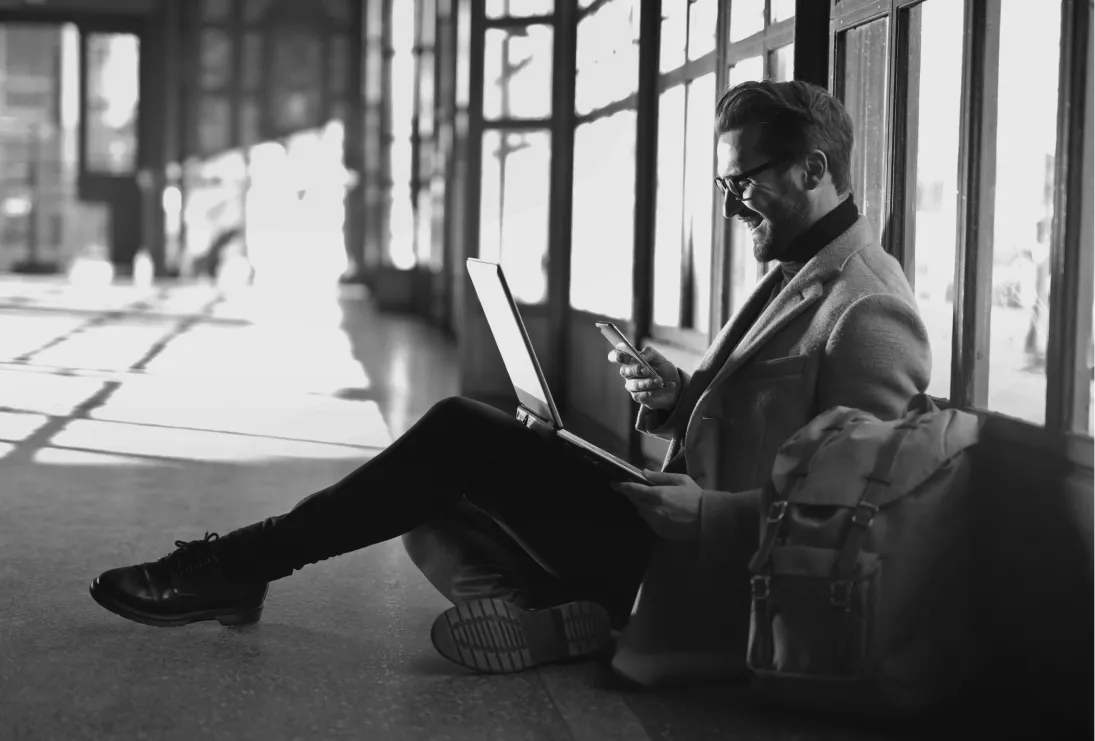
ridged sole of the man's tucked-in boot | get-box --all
[430,600,612,674]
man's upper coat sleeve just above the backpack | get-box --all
[815,293,932,420]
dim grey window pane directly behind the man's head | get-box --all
[839,18,889,245]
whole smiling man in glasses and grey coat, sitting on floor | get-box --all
[91,82,931,683]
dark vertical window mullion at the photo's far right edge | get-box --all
[1046,0,1095,432]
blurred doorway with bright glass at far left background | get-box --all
[0,20,141,274]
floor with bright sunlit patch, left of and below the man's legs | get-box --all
[0,278,994,741]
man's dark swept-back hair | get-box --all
[715,80,854,194]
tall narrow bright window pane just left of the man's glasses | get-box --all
[684,72,715,332]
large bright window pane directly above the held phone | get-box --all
[570,111,635,319]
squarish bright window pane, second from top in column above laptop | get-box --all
[483,24,554,118]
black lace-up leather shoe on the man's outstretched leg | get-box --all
[90,533,269,627]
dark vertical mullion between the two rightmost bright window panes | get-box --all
[950,0,1000,408]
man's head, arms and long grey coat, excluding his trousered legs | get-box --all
[610,82,931,683]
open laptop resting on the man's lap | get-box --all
[468,257,650,484]
